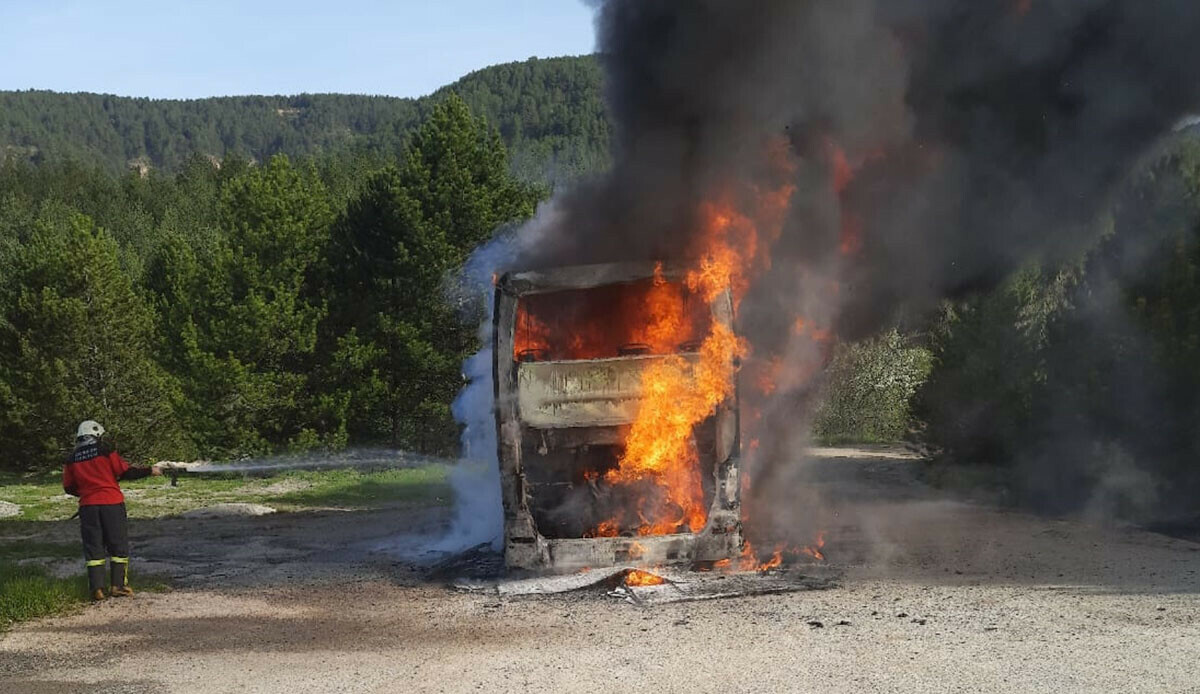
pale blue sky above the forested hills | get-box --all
[0,0,594,98]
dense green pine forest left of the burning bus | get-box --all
[0,95,545,467]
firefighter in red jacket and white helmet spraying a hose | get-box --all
[62,419,162,600]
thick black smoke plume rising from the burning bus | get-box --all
[484,0,1200,528]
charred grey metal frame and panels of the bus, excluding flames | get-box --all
[492,263,742,573]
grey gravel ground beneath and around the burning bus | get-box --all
[0,455,1200,694]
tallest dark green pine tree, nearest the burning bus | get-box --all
[325,96,536,450]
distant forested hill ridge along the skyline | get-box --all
[0,56,610,180]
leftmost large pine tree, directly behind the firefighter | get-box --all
[0,215,188,467]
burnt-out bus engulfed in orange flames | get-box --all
[493,263,743,573]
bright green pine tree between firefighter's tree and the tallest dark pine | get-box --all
[150,156,341,455]
